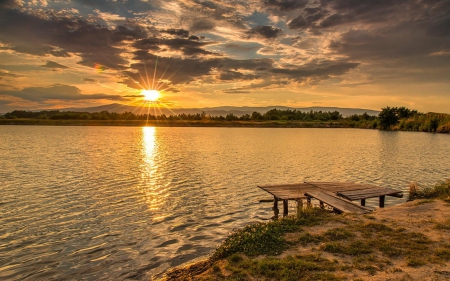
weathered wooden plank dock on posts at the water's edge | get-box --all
[258,182,403,217]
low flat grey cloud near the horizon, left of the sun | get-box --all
[0,84,123,101]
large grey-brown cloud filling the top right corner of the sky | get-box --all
[329,1,450,64]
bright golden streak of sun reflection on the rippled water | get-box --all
[140,127,167,211]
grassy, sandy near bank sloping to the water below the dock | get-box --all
[165,181,450,280]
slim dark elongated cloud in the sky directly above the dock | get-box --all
[271,61,359,81]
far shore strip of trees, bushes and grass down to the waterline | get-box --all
[0,107,450,133]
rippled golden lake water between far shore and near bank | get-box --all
[0,126,450,280]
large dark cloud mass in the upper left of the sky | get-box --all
[0,9,143,68]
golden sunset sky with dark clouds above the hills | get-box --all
[0,0,450,113]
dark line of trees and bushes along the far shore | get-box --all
[0,106,450,133]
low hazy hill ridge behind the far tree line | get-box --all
[60,103,380,117]
